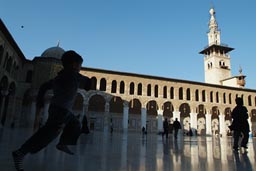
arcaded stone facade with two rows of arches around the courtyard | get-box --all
[0,7,256,136]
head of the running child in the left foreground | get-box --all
[61,50,83,71]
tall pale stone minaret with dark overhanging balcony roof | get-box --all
[199,8,233,85]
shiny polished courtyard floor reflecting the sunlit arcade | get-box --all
[0,128,256,171]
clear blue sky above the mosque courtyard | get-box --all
[0,0,256,89]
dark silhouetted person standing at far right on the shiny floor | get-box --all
[229,97,250,151]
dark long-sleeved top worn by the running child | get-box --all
[37,69,91,112]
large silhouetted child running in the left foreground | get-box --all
[12,50,91,171]
